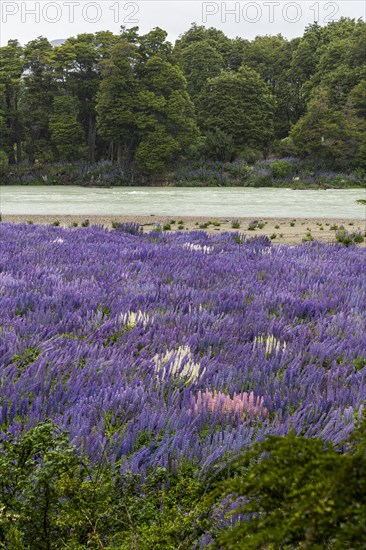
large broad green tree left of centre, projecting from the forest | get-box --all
[97,29,197,174]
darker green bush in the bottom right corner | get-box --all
[213,413,366,550]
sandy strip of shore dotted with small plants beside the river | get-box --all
[2,215,366,246]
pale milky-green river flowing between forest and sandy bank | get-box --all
[0,186,366,219]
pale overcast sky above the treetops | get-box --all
[0,0,366,45]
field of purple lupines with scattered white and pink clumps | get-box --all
[0,223,366,479]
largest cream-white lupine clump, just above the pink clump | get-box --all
[154,346,205,382]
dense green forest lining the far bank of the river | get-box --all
[0,18,366,186]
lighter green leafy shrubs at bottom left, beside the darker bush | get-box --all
[0,422,209,550]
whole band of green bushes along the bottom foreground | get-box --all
[0,417,366,550]
